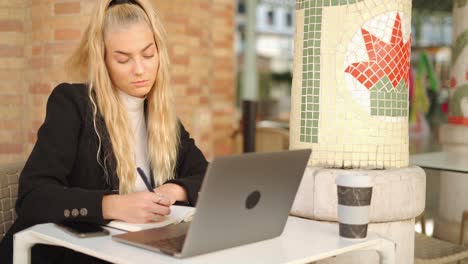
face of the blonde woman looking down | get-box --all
[104,22,159,97]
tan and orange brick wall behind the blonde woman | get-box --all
[0,0,235,164]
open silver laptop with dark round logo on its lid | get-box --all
[112,149,311,257]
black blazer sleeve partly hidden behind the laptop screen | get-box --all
[167,124,208,206]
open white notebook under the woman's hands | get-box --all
[107,205,195,232]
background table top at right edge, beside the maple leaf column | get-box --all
[409,152,468,173]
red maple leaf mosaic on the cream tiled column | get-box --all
[345,13,411,89]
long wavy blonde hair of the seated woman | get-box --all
[68,0,180,194]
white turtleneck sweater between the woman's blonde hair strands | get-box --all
[119,90,151,191]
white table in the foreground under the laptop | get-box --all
[14,216,395,264]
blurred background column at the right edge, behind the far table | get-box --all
[434,0,468,242]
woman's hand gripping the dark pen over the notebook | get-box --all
[102,192,171,223]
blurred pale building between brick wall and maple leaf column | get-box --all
[235,0,296,122]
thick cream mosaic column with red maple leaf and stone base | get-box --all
[290,0,425,263]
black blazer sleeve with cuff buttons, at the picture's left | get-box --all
[16,84,108,225]
